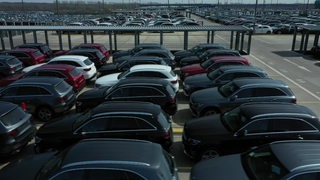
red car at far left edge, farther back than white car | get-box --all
[1,48,47,66]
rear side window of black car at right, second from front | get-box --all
[271,119,316,132]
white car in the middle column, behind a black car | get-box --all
[95,64,179,92]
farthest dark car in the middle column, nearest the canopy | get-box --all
[112,43,166,60]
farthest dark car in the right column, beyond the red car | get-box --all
[173,43,225,65]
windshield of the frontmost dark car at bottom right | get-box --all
[241,146,289,180]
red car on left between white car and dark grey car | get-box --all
[0,64,86,92]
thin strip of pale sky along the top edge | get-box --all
[0,0,315,4]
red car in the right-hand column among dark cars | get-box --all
[180,56,250,80]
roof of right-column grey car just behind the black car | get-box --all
[232,77,288,88]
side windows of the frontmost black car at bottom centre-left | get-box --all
[51,169,144,180]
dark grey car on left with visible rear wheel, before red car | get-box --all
[0,77,76,121]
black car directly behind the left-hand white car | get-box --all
[66,48,108,69]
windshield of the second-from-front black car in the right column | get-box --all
[221,108,248,132]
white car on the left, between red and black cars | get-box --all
[47,55,97,80]
